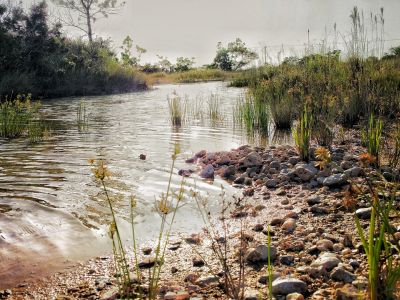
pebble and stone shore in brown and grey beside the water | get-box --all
[0,132,400,300]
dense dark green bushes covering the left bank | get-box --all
[0,2,146,98]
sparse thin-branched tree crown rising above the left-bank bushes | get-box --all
[51,0,125,42]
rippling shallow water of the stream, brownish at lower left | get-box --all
[0,82,290,288]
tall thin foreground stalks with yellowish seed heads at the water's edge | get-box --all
[89,146,184,299]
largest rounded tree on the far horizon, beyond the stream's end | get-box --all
[213,38,258,71]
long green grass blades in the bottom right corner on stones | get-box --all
[355,173,400,300]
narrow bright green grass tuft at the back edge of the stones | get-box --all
[292,106,313,161]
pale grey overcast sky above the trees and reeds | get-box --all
[19,0,400,65]
